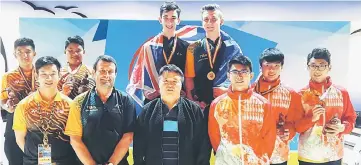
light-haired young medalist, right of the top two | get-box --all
[185,4,241,116]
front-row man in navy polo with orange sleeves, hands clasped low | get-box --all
[65,55,136,165]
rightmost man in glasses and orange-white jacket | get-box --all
[289,48,356,165]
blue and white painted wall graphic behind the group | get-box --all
[19,18,361,150]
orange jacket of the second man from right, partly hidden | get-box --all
[253,76,302,164]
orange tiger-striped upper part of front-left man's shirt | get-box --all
[13,91,73,141]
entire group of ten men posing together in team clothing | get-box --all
[0,2,356,165]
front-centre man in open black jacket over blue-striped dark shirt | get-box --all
[133,64,211,165]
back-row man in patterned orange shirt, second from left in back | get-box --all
[58,36,95,99]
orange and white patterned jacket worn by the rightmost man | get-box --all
[293,77,356,163]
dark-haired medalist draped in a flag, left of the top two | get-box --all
[128,2,189,104]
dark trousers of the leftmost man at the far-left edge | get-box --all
[4,136,24,165]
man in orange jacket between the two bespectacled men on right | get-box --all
[253,48,302,165]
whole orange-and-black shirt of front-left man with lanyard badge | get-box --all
[13,91,76,165]
